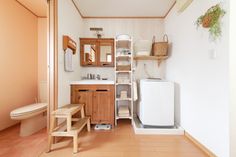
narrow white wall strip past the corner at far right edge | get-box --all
[229,0,236,157]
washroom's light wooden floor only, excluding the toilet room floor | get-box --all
[41,121,207,157]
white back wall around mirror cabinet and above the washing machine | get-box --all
[81,19,165,79]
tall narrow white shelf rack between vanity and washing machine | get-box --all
[115,35,133,125]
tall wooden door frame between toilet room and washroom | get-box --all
[47,0,58,131]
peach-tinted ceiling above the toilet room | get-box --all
[17,0,47,17]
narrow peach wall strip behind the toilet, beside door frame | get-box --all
[38,18,47,92]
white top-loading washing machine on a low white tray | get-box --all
[137,79,174,127]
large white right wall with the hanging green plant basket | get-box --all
[165,0,229,157]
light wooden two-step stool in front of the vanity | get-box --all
[48,104,90,153]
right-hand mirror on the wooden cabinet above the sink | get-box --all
[100,45,112,63]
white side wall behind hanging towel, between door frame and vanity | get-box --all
[58,0,83,106]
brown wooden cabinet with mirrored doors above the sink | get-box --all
[80,38,114,67]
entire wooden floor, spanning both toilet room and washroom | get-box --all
[0,121,207,157]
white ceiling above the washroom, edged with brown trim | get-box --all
[74,0,176,18]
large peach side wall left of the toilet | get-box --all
[0,0,38,130]
